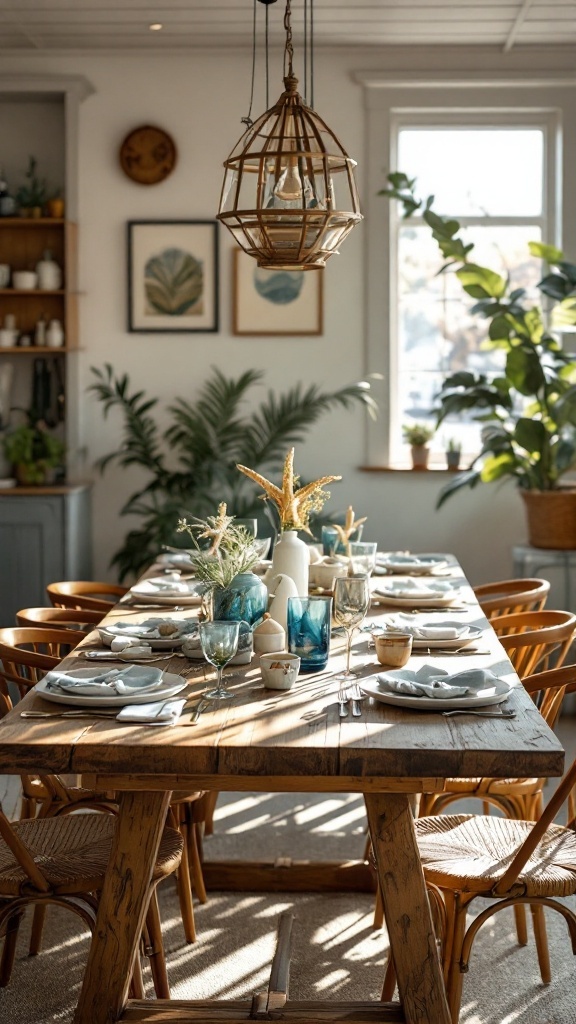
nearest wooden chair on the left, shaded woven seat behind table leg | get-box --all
[0,807,182,998]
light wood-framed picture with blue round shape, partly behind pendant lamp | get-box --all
[233,249,324,337]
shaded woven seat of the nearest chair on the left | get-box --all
[0,814,182,899]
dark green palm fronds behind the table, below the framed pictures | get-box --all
[88,364,375,580]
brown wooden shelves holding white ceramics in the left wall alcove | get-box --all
[0,217,78,356]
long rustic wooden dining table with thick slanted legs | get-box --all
[0,559,564,1024]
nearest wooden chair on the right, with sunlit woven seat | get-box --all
[409,741,576,1024]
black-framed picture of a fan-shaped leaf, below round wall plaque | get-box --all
[127,220,219,334]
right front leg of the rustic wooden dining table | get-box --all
[365,793,450,1024]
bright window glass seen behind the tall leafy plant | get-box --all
[390,120,546,462]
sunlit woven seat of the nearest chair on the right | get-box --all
[414,814,576,897]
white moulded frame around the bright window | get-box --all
[355,73,576,467]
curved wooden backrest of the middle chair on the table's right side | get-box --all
[490,609,576,679]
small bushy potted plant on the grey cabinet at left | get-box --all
[2,413,66,486]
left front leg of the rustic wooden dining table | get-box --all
[74,791,170,1024]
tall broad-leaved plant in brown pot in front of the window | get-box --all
[382,172,576,549]
